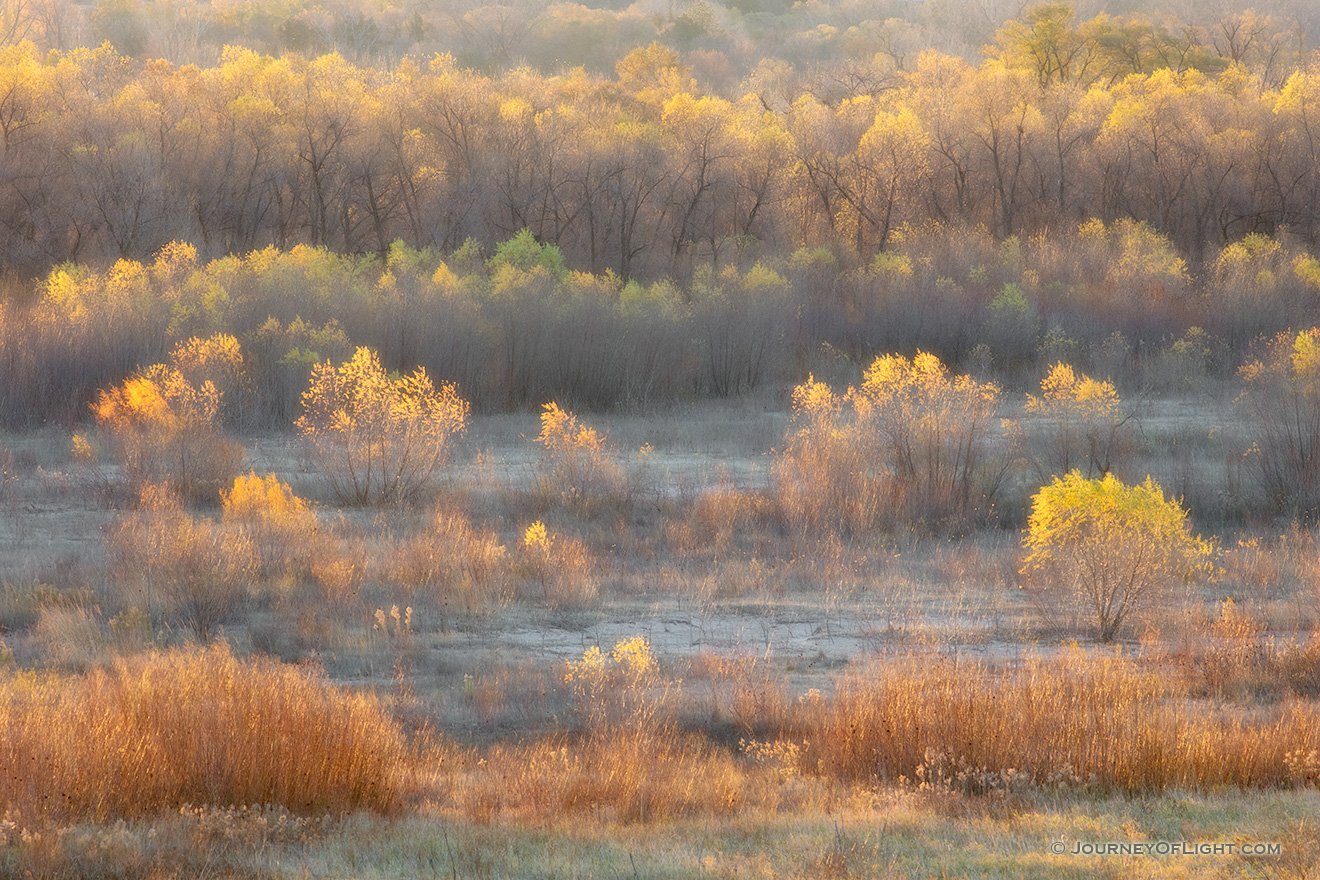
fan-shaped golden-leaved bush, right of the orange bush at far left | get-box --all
[297,348,469,504]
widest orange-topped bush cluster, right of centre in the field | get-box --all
[775,352,1007,534]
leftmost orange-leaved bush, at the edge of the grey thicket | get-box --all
[92,336,243,501]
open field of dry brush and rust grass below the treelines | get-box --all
[0,389,1320,877]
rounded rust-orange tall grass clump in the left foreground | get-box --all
[0,644,405,822]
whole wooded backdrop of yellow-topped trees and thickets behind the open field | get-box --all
[0,0,1320,427]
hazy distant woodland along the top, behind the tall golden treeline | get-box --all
[0,0,1320,83]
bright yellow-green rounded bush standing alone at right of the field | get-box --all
[1023,471,1212,641]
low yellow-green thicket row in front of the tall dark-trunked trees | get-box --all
[0,220,1320,429]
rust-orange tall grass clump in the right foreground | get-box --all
[804,652,1320,793]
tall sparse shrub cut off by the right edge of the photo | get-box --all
[1238,327,1320,521]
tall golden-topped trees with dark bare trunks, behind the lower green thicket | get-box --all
[0,5,1320,275]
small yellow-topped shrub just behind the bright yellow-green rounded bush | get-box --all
[1027,361,1131,480]
